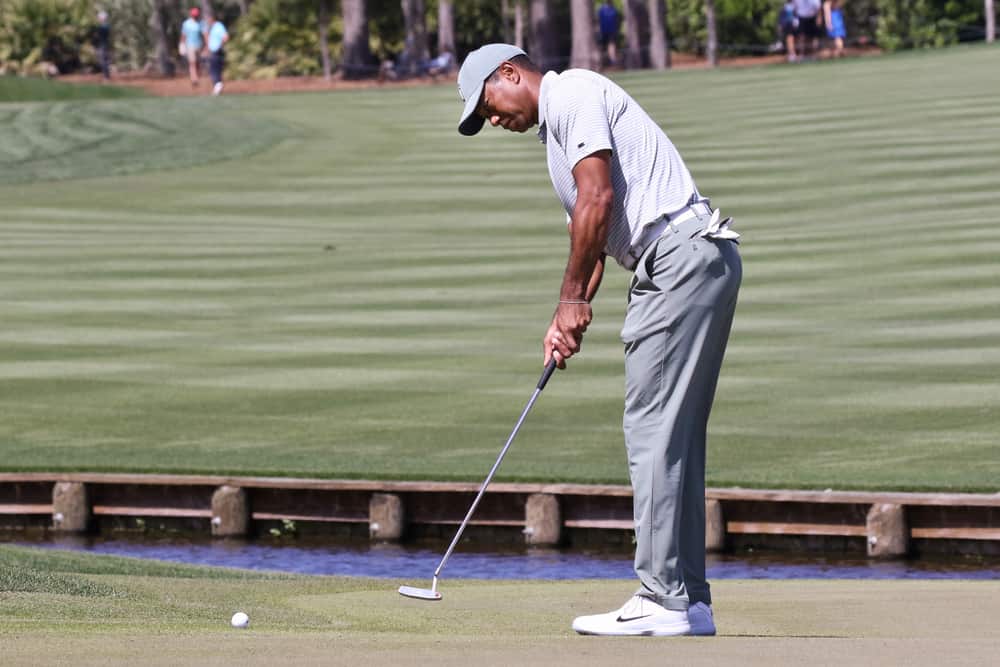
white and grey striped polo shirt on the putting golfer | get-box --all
[538,69,697,270]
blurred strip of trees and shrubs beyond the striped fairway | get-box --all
[0,0,995,79]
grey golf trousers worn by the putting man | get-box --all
[622,215,743,610]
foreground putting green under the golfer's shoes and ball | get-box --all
[0,547,1000,667]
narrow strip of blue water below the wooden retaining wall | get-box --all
[7,535,1000,580]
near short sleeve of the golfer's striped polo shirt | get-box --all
[546,79,613,169]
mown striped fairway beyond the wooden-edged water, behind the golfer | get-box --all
[0,47,1000,491]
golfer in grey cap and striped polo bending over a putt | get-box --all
[458,44,742,635]
